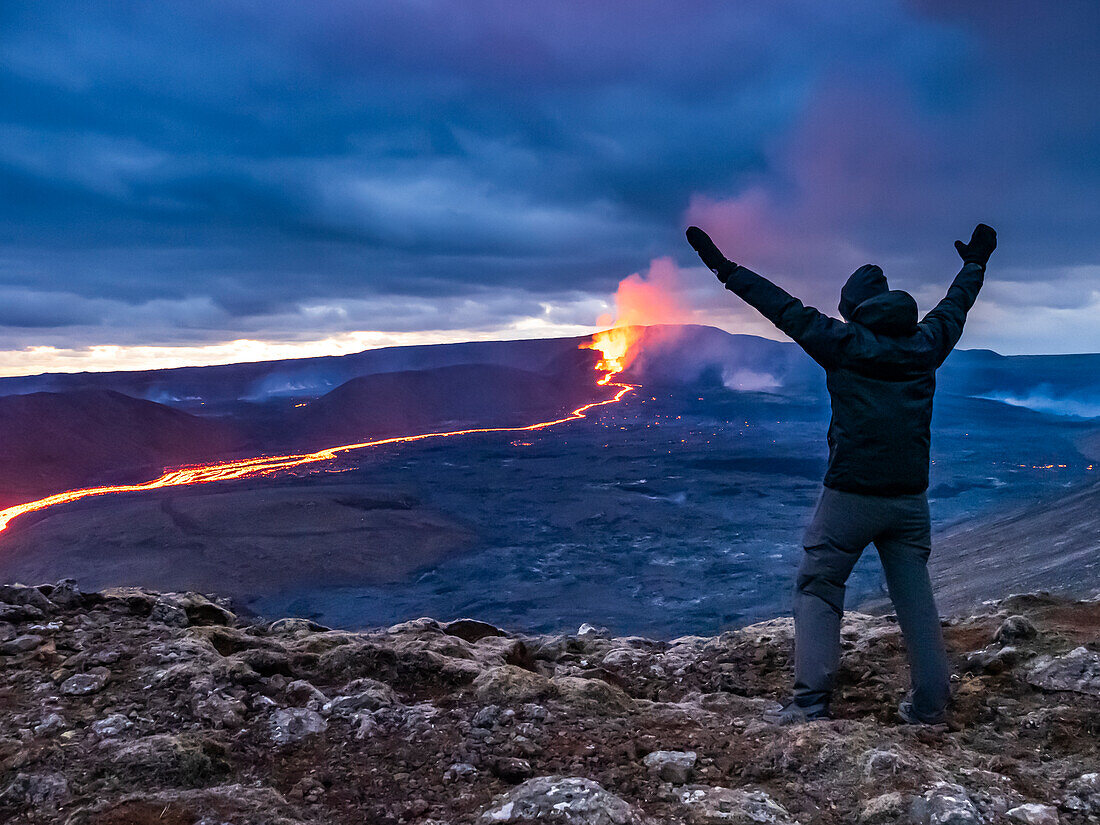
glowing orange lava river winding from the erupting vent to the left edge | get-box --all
[0,347,635,531]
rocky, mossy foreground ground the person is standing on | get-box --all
[0,581,1100,825]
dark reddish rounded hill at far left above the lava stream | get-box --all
[0,389,239,506]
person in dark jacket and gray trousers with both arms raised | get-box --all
[688,223,997,725]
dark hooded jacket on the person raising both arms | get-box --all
[726,264,985,496]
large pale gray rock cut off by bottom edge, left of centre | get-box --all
[479,776,655,825]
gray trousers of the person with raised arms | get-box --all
[794,487,950,722]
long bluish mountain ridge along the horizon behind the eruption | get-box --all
[0,325,1100,422]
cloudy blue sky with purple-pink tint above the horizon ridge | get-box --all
[0,0,1100,374]
